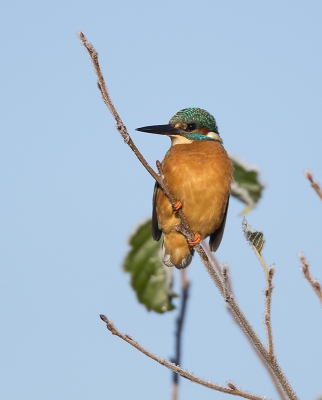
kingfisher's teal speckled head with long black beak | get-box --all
[136,108,222,145]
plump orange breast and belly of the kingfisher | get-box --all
[156,141,233,238]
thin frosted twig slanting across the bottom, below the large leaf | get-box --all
[100,315,267,400]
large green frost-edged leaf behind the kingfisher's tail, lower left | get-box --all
[123,220,177,313]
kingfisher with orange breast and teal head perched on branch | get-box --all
[136,108,233,269]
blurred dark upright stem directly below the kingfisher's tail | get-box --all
[172,269,190,400]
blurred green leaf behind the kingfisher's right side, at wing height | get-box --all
[230,156,264,215]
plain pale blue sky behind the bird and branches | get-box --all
[0,0,322,400]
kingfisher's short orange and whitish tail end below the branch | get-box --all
[162,232,194,269]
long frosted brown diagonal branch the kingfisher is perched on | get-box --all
[78,32,298,400]
